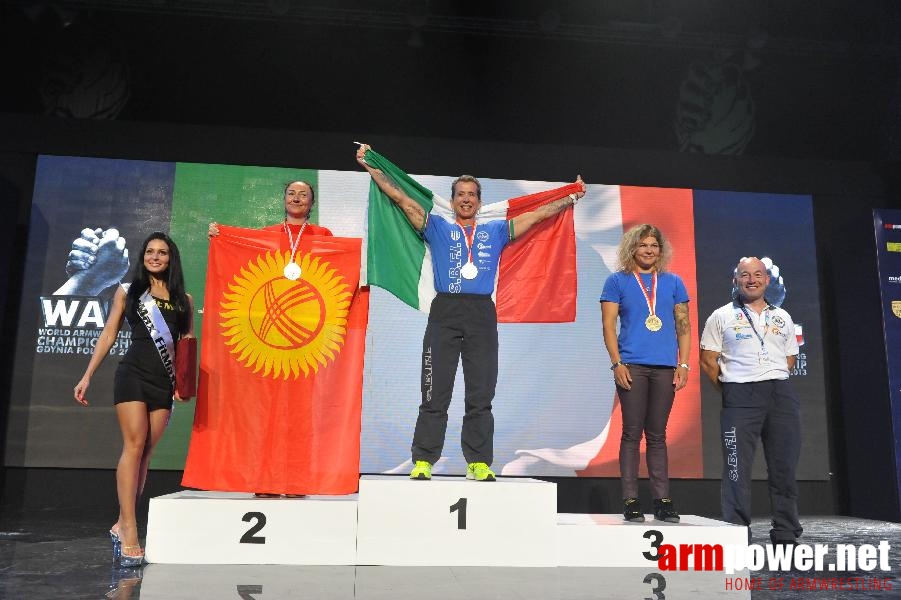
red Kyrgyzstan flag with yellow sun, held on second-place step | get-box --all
[182,225,369,495]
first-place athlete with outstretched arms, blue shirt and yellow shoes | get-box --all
[357,144,585,481]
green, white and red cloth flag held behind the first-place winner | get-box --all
[365,150,581,323]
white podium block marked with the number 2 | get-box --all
[145,491,357,565]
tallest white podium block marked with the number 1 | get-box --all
[357,475,557,567]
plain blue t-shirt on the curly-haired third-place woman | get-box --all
[601,271,688,367]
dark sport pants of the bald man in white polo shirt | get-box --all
[720,379,803,541]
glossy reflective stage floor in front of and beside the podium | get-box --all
[0,509,901,600]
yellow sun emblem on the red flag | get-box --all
[219,252,353,379]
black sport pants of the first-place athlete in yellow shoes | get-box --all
[412,294,498,465]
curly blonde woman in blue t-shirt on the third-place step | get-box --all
[601,224,691,523]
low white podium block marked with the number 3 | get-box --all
[557,513,748,569]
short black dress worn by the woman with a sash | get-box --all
[113,298,178,410]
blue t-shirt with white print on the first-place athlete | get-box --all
[422,215,510,296]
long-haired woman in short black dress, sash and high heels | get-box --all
[75,232,194,566]
